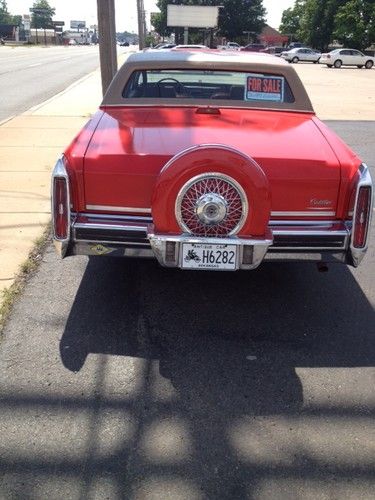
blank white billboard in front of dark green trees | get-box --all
[167,4,219,28]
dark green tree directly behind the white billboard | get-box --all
[152,0,266,40]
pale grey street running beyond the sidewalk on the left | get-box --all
[0,46,123,121]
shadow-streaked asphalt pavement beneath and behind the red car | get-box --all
[0,121,375,500]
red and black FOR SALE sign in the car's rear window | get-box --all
[245,74,285,102]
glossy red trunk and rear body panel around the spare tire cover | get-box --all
[65,107,360,220]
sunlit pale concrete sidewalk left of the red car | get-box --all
[0,57,123,304]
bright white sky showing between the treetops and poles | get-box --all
[7,0,294,32]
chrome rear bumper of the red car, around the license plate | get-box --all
[58,214,356,269]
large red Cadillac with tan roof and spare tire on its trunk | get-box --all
[52,51,373,270]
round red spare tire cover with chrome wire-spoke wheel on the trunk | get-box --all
[152,144,271,237]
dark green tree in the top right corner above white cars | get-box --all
[333,0,375,49]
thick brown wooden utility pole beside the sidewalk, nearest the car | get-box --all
[97,0,117,95]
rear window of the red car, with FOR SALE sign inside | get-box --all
[122,69,295,104]
